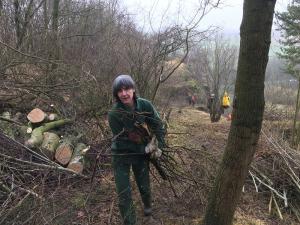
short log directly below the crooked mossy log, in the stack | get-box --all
[41,132,59,160]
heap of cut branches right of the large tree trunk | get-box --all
[249,130,300,221]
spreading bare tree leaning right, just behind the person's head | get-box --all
[120,0,223,101]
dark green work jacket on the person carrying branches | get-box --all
[108,98,165,153]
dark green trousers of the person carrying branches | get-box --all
[113,156,151,225]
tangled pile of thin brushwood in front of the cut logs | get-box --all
[0,128,94,225]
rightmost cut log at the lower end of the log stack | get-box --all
[67,143,89,174]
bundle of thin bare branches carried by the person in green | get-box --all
[150,108,220,192]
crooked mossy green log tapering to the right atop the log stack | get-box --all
[25,119,71,147]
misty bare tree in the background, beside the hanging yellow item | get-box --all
[189,34,237,122]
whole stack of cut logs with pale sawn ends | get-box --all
[0,108,89,173]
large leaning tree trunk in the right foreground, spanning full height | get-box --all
[203,0,276,225]
